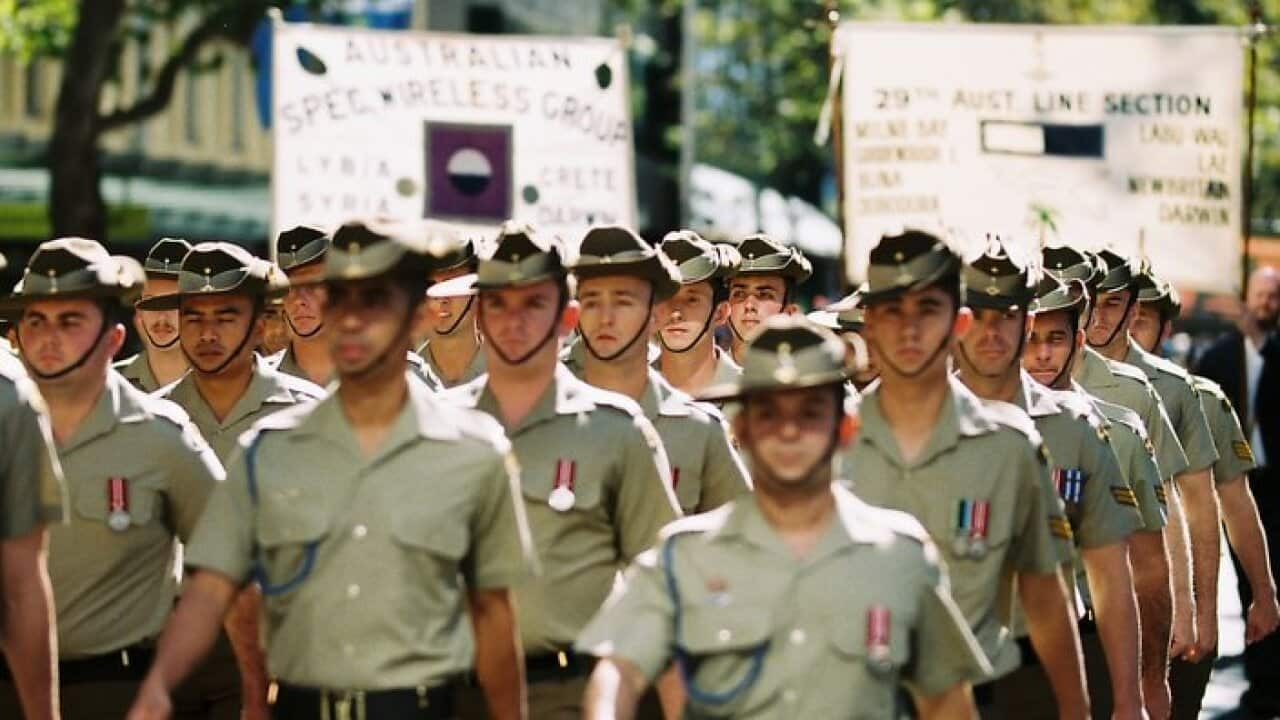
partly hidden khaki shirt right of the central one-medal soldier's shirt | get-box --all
[640,370,751,514]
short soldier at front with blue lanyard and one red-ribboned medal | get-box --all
[577,316,989,719]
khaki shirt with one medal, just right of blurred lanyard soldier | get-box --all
[444,365,680,656]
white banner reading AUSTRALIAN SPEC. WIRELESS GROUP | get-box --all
[271,23,635,246]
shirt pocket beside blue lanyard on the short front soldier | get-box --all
[676,606,777,717]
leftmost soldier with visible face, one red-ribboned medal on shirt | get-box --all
[0,238,223,719]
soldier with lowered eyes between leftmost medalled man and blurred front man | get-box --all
[138,242,323,717]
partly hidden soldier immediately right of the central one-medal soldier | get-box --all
[572,225,749,512]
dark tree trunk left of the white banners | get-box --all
[49,0,124,243]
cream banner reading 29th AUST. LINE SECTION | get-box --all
[836,23,1244,292]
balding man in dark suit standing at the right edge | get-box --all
[1196,266,1280,717]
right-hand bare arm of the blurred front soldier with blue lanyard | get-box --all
[467,588,529,720]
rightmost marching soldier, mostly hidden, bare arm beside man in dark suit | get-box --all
[1129,263,1280,720]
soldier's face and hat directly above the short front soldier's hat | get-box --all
[727,233,813,364]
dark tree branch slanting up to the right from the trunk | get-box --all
[96,0,266,132]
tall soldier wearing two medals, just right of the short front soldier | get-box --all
[842,231,1089,719]
